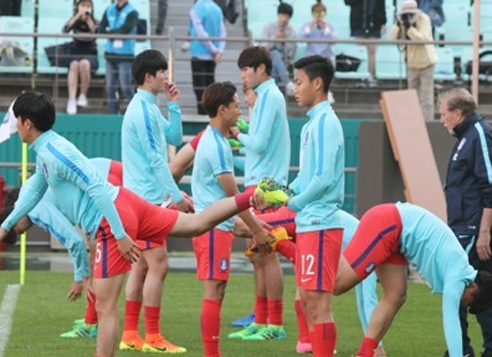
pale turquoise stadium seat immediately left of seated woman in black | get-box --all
[37,17,72,73]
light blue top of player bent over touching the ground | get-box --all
[396,202,477,357]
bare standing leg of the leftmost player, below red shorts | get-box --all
[92,274,125,357]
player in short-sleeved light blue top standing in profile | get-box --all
[191,82,271,357]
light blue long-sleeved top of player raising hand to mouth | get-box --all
[121,89,183,204]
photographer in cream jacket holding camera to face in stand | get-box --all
[389,0,437,121]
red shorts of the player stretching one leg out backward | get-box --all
[94,187,179,278]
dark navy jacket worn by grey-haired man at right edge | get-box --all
[445,114,492,235]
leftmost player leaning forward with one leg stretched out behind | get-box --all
[0,92,265,357]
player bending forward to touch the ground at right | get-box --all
[334,203,492,357]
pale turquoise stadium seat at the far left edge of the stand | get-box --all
[0,16,34,73]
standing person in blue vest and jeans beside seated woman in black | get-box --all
[99,0,138,114]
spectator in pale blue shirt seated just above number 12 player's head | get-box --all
[299,0,338,104]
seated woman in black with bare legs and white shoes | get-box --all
[63,0,99,115]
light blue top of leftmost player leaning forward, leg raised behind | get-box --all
[2,130,127,239]
